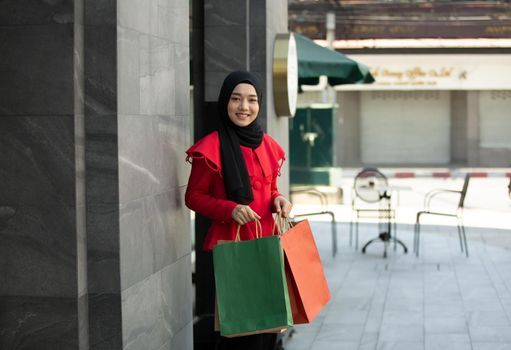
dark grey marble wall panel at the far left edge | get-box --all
[0,1,83,349]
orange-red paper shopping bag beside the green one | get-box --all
[279,220,330,324]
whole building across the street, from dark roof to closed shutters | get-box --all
[290,1,511,167]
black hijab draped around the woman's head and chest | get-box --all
[218,71,263,204]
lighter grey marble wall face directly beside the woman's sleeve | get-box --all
[117,0,193,350]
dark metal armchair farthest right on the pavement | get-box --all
[413,174,470,257]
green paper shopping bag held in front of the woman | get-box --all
[213,221,293,337]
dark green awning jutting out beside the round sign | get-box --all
[293,33,374,86]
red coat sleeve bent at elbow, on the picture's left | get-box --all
[185,158,237,222]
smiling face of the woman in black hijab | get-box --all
[227,83,259,127]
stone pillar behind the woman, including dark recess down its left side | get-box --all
[193,0,289,348]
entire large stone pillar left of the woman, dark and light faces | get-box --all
[0,0,193,350]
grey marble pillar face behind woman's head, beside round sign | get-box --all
[204,0,289,193]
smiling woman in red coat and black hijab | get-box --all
[185,71,292,349]
